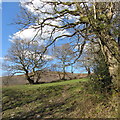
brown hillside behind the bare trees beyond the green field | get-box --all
[2,71,87,85]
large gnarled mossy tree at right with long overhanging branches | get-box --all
[12,0,120,89]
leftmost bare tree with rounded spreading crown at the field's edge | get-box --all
[3,40,49,84]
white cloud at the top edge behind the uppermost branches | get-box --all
[20,0,76,19]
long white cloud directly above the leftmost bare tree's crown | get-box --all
[9,25,70,45]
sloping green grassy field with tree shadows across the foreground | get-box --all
[3,78,118,120]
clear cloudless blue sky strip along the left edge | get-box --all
[0,2,20,76]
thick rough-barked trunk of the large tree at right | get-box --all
[99,32,120,90]
